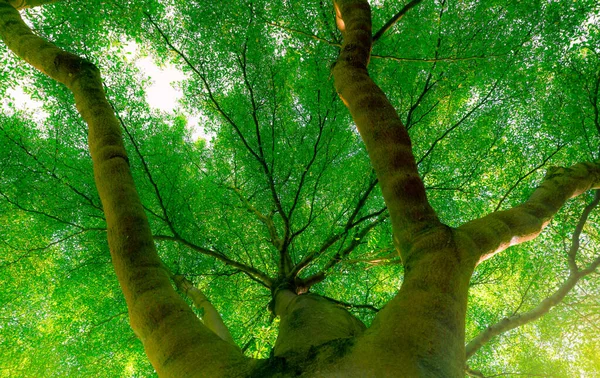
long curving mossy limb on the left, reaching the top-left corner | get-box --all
[0,0,245,377]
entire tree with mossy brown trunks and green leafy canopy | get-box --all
[0,0,600,377]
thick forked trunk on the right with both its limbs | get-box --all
[332,0,600,377]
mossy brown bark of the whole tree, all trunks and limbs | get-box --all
[0,0,600,377]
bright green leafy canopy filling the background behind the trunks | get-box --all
[0,0,600,377]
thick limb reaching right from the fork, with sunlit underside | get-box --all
[457,163,600,261]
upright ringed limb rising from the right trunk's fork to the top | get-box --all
[332,0,439,253]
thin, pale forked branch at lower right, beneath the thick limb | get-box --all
[466,191,600,358]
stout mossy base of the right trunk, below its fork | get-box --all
[344,226,475,377]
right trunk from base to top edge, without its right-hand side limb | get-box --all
[333,0,475,377]
